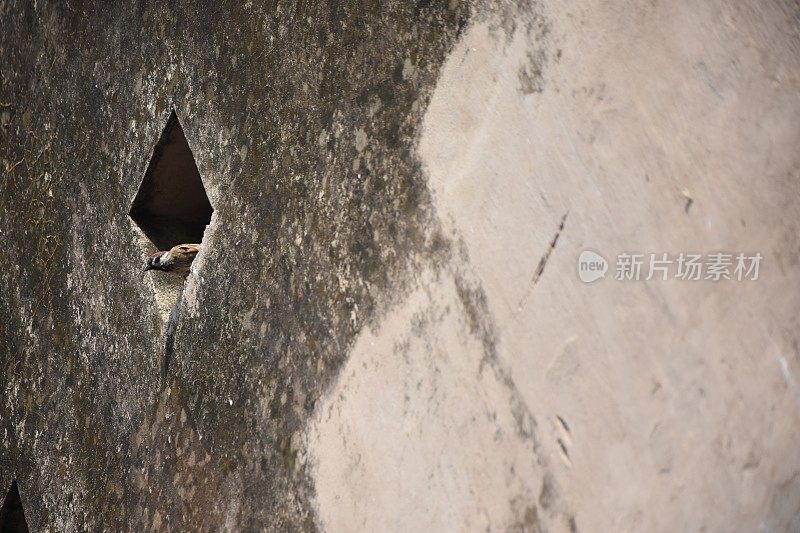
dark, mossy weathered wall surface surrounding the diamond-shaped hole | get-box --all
[0,2,467,529]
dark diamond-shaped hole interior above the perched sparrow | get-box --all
[128,110,214,250]
